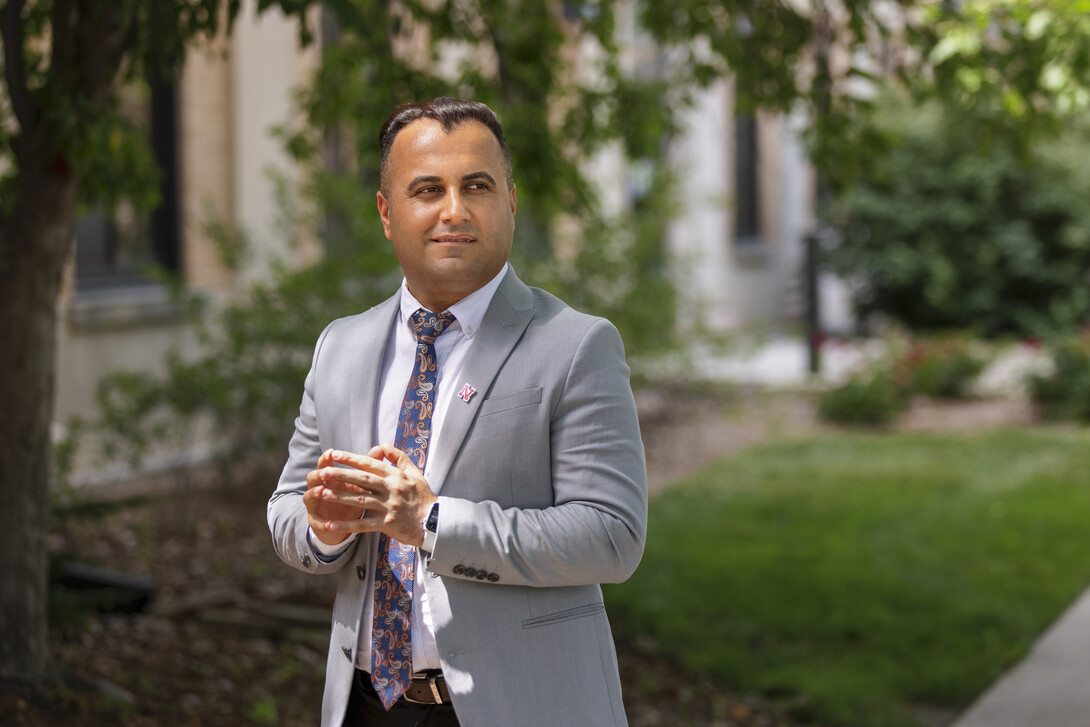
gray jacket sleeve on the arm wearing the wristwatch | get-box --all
[427,318,647,586]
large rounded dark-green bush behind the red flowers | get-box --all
[827,102,1090,338]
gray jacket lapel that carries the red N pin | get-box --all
[427,270,534,494]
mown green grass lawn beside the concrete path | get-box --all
[606,428,1090,727]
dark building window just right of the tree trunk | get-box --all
[75,74,181,291]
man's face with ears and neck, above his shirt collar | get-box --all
[378,119,514,313]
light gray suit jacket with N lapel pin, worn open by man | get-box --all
[268,270,647,727]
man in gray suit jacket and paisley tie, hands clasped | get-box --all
[268,98,646,727]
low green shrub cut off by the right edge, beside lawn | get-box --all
[1027,332,1090,422]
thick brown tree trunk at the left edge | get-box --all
[0,154,75,680]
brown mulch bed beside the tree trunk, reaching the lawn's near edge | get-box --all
[0,475,792,727]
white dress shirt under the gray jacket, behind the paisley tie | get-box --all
[307,266,509,671]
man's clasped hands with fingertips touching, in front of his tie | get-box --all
[303,445,438,547]
